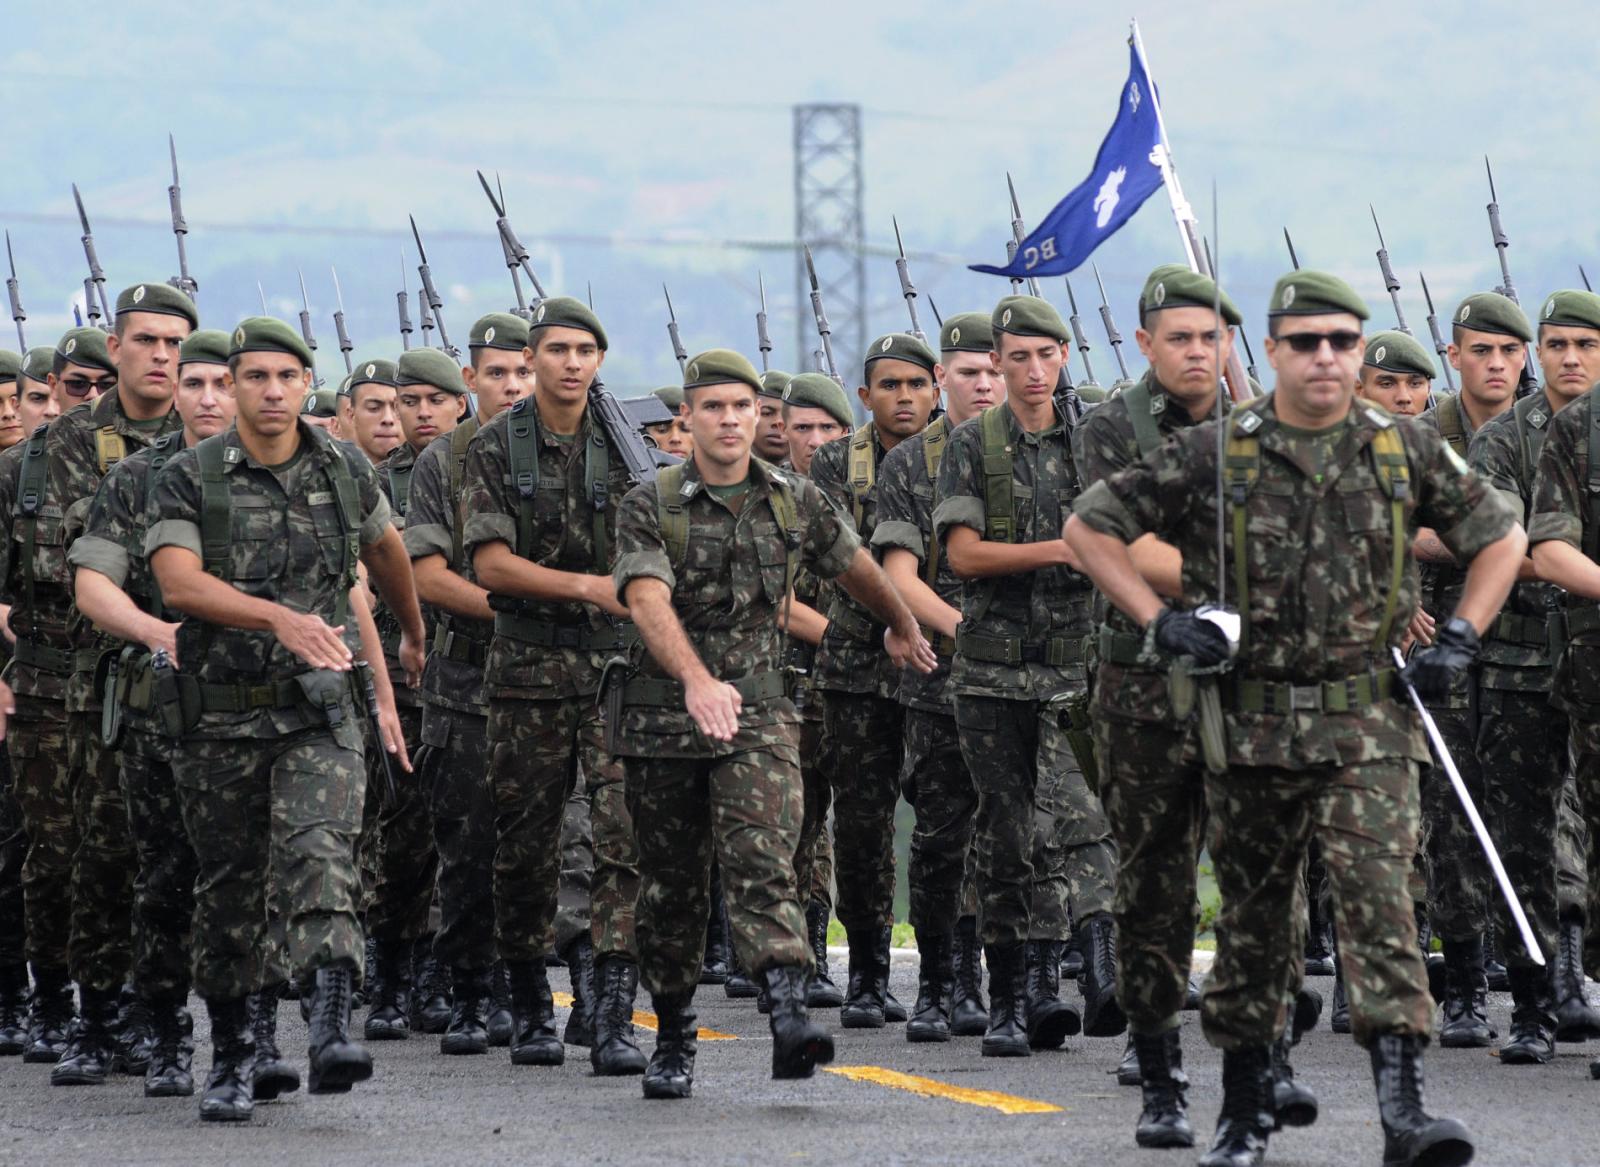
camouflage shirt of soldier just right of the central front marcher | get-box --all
[811,421,899,698]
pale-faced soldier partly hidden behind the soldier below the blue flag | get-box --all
[872,312,992,1042]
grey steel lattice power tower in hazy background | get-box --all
[794,104,867,383]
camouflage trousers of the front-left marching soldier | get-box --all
[173,720,366,1001]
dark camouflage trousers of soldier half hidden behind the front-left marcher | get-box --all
[118,724,195,997]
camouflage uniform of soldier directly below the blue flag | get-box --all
[933,403,1117,948]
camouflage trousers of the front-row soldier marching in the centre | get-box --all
[626,742,813,999]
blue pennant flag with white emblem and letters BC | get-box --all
[971,45,1165,279]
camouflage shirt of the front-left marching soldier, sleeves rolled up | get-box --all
[144,421,390,743]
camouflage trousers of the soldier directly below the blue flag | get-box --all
[955,695,1117,944]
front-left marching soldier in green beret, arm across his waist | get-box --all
[146,317,422,1122]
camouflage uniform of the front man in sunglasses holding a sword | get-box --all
[1075,397,1515,1050]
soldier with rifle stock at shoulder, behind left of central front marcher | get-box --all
[462,296,645,1074]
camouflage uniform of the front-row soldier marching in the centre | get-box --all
[613,458,861,1001]
